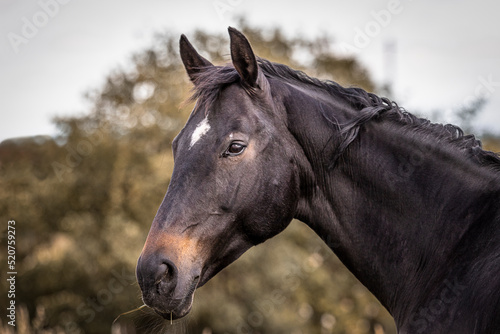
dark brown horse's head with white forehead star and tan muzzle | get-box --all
[137,28,300,319]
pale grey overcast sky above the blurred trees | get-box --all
[0,0,500,141]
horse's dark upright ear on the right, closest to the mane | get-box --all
[228,27,259,87]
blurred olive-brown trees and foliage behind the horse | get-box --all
[0,15,500,334]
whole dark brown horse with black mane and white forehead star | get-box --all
[136,27,500,334]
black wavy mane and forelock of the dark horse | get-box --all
[191,58,500,172]
